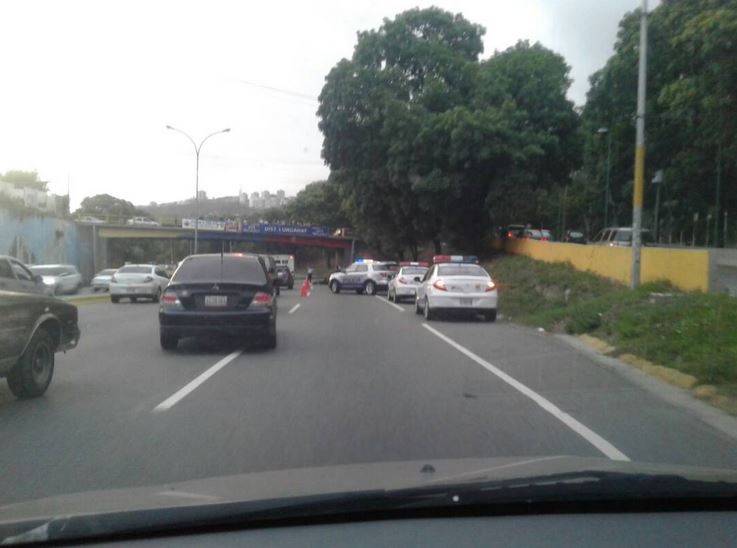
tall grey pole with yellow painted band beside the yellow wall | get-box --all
[630,0,647,289]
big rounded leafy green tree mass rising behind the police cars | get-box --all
[318,8,580,255]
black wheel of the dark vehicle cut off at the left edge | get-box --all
[8,329,55,398]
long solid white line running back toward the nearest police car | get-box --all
[422,323,630,461]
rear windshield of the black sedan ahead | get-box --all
[173,256,266,285]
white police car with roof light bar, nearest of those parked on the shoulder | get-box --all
[415,255,497,322]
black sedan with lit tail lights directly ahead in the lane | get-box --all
[159,253,277,350]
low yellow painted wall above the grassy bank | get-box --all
[505,239,709,291]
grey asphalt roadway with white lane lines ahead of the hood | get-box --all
[0,286,737,503]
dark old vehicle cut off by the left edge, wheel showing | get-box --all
[0,291,79,398]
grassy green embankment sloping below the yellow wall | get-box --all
[487,256,737,397]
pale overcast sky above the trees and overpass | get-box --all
[0,0,652,208]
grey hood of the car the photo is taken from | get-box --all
[0,456,737,541]
